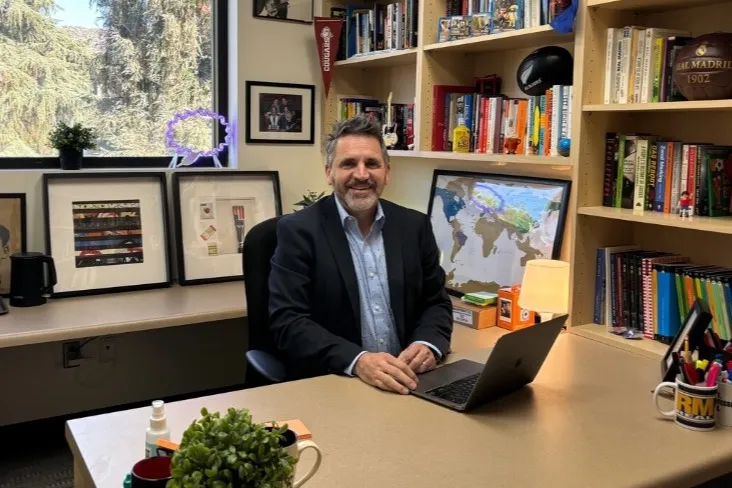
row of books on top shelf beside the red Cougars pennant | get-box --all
[330,0,419,60]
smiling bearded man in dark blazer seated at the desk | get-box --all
[269,115,452,394]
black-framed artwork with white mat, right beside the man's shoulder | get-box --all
[173,170,282,285]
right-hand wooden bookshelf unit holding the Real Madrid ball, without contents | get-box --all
[569,0,732,359]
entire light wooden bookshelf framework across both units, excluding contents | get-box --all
[322,0,732,358]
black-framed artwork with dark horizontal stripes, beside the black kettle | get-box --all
[43,172,172,298]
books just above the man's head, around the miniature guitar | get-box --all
[338,95,414,151]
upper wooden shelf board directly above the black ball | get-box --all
[424,25,573,54]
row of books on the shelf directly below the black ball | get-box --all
[432,85,572,156]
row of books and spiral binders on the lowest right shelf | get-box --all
[594,245,732,343]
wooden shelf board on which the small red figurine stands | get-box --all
[577,207,732,234]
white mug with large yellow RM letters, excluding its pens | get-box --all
[653,375,719,432]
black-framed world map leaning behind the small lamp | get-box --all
[427,170,571,296]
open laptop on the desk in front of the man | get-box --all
[412,315,568,411]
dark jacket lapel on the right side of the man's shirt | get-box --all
[381,202,406,341]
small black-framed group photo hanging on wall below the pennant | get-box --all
[246,81,315,144]
